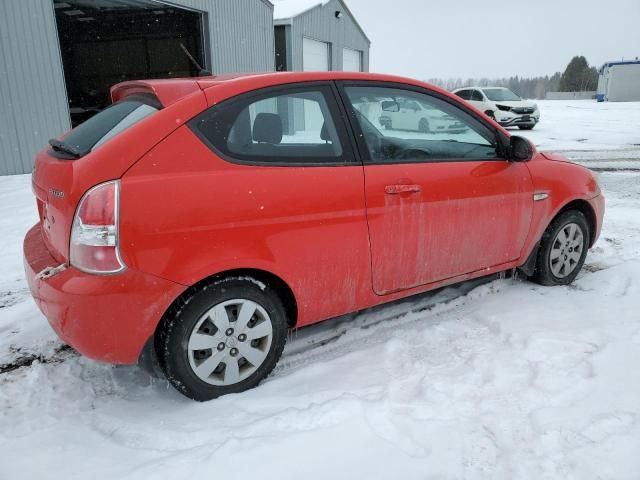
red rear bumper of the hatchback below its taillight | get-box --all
[24,224,186,364]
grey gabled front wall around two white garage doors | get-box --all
[291,0,369,72]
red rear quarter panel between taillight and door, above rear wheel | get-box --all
[121,128,371,324]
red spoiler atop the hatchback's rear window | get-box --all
[111,78,201,107]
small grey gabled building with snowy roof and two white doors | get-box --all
[274,0,371,72]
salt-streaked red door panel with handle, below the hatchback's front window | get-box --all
[365,160,533,295]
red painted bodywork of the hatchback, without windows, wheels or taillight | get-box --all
[24,72,604,363]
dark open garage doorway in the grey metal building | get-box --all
[53,0,207,127]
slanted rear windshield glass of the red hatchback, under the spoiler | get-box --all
[57,100,159,155]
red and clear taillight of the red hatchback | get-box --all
[69,180,125,274]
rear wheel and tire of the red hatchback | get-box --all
[156,278,287,402]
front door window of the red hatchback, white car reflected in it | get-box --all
[345,86,498,163]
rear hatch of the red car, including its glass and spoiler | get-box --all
[32,79,206,263]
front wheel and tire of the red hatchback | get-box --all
[532,210,591,285]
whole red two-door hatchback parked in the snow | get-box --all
[24,72,604,400]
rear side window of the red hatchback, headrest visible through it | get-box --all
[190,87,343,163]
